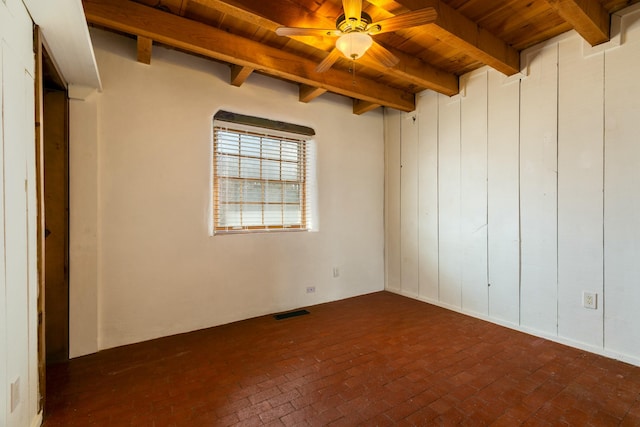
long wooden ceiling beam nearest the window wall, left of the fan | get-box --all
[83,0,415,111]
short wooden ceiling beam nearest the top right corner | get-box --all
[547,0,611,46]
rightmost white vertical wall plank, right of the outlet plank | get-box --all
[604,5,640,363]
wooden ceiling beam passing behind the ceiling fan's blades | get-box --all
[191,0,458,96]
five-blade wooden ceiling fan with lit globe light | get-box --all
[276,0,438,73]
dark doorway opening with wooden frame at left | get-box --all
[35,34,69,409]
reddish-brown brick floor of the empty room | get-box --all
[44,292,640,427]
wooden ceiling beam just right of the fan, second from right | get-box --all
[395,0,520,76]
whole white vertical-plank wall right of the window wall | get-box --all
[385,6,640,365]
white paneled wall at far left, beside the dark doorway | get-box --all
[0,0,41,427]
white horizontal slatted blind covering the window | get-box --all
[213,120,314,233]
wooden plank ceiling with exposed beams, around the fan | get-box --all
[83,0,640,114]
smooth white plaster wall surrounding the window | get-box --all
[70,30,384,356]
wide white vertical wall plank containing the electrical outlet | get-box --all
[558,37,604,347]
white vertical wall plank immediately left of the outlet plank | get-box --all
[520,44,558,335]
